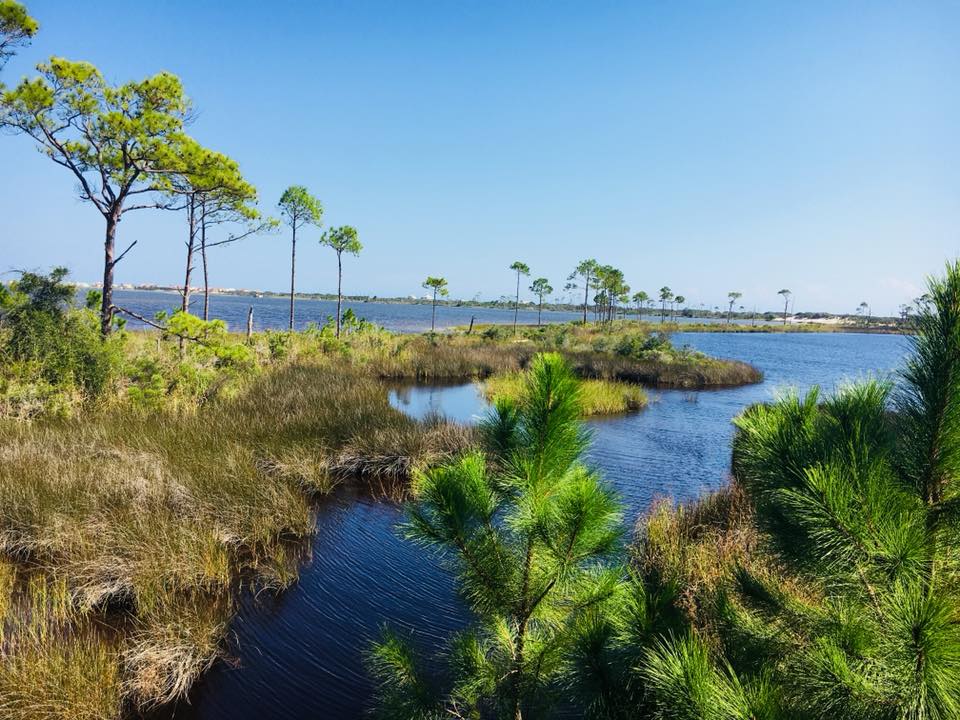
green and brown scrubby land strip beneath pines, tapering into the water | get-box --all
[0,318,762,421]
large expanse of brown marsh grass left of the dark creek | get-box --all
[0,359,472,719]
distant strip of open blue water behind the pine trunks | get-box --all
[114,290,765,332]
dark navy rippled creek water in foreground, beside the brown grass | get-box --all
[162,489,468,720]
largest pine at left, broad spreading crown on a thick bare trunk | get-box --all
[0,57,194,334]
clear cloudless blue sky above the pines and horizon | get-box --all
[0,0,960,313]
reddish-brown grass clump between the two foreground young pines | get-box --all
[630,480,822,692]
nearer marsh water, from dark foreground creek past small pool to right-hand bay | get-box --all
[165,333,906,720]
